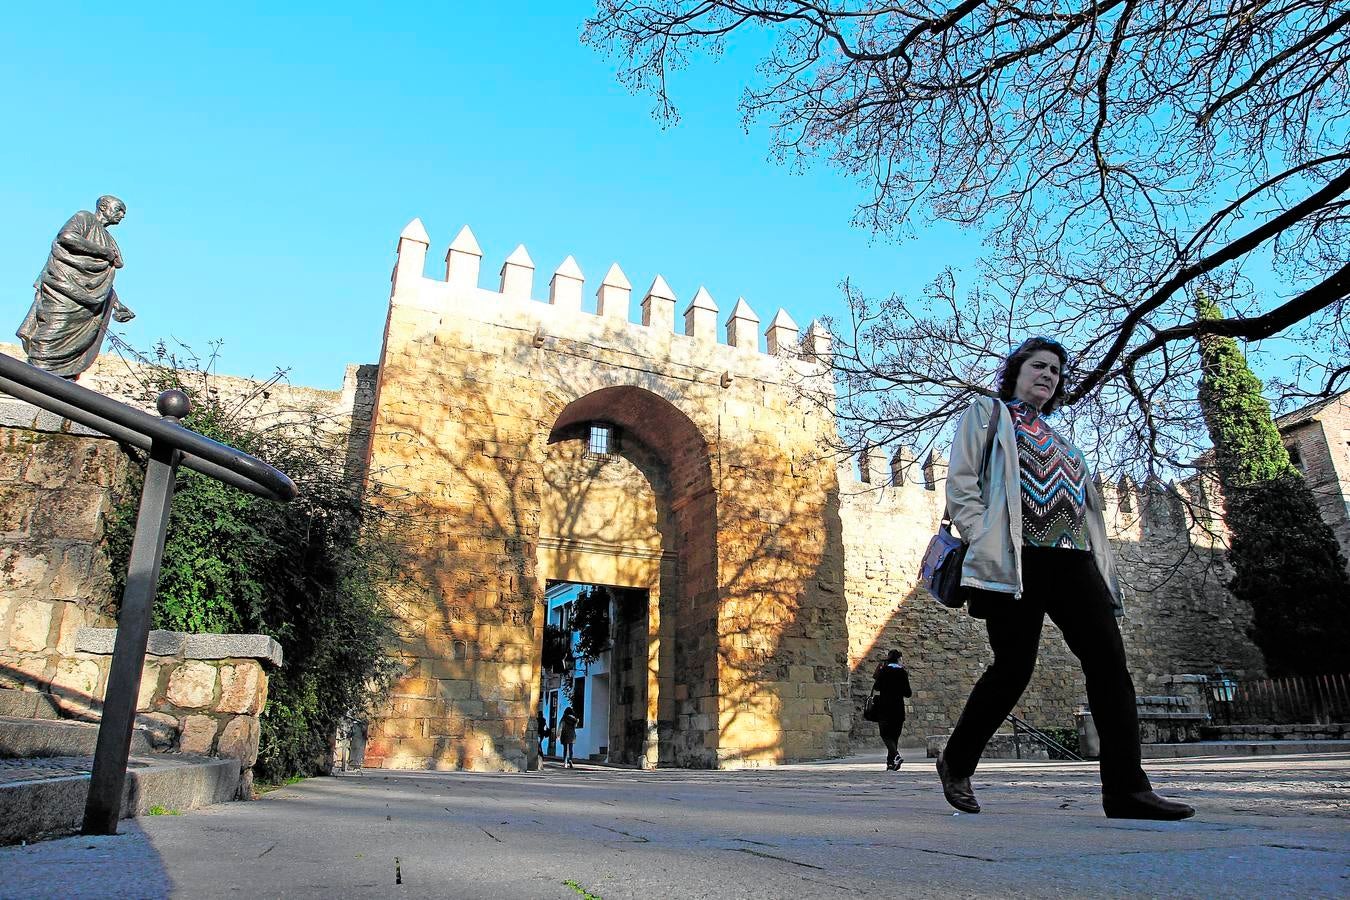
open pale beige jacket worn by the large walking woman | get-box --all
[946,397,1125,615]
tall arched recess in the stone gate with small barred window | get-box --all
[536,387,717,768]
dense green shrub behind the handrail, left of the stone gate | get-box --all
[105,348,400,781]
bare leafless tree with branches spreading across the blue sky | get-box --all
[583,0,1350,475]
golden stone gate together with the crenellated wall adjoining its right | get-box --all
[353,220,1261,770]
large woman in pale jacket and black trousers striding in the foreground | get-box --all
[937,337,1195,819]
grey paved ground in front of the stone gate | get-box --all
[0,754,1350,900]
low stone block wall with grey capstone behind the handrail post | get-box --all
[66,627,282,800]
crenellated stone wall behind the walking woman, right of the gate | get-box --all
[841,459,1265,748]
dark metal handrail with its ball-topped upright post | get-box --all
[0,354,298,834]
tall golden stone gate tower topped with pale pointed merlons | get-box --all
[366,221,849,769]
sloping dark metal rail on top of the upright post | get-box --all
[0,354,296,502]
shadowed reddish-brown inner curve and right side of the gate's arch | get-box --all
[537,385,718,768]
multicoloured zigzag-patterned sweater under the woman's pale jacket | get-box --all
[1007,399,1088,551]
